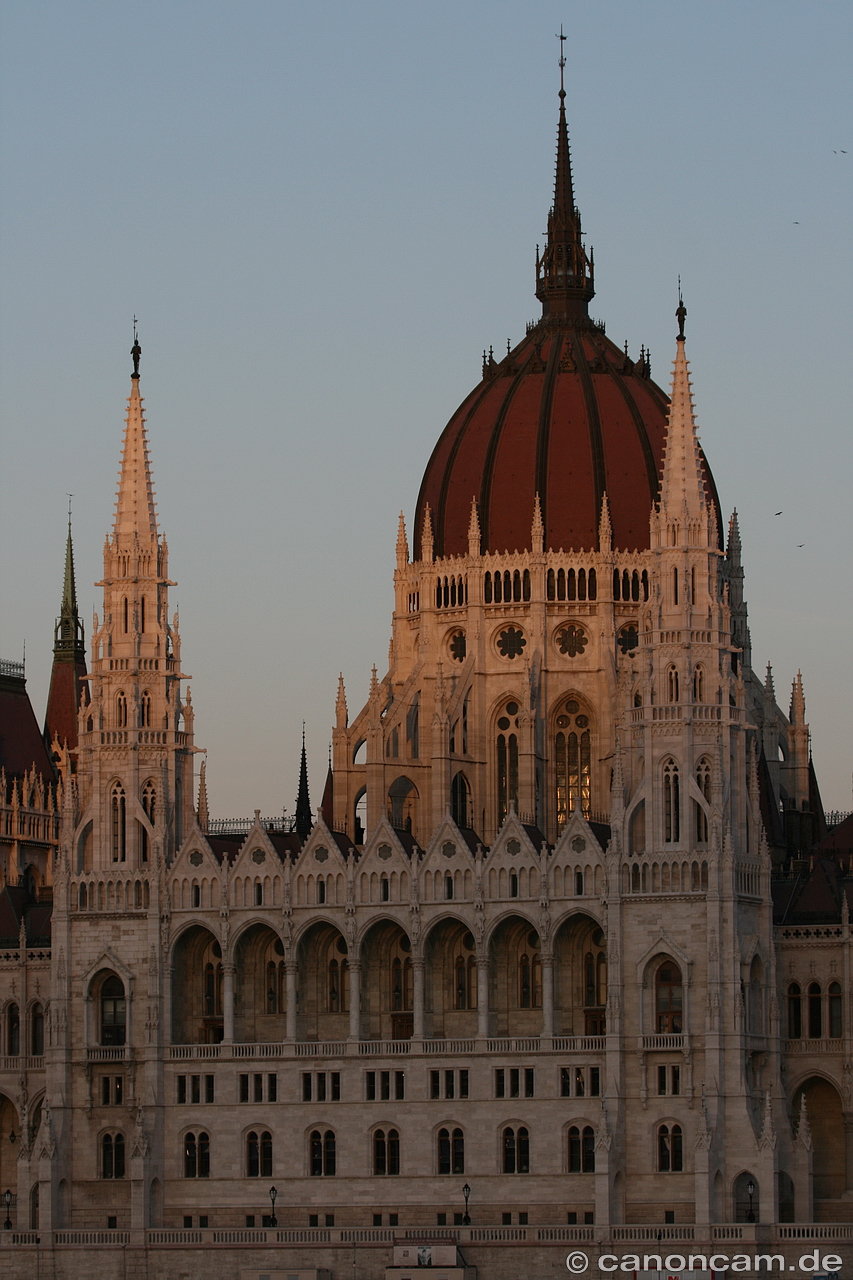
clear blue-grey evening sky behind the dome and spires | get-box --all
[0,0,853,817]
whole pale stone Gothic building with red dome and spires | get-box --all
[0,67,853,1280]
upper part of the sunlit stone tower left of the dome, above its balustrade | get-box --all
[70,332,193,872]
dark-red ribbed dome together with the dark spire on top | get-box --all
[412,88,722,559]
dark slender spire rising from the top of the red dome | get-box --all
[537,27,596,321]
